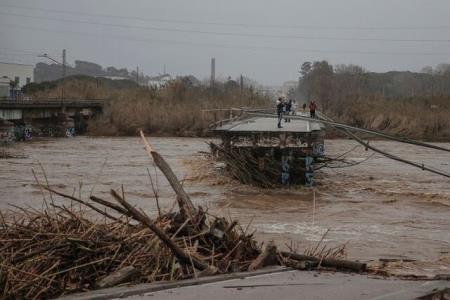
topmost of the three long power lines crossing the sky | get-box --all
[0,4,450,30]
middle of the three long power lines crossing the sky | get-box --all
[0,12,450,43]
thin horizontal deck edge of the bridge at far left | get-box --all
[0,99,104,108]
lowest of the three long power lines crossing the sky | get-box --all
[3,24,450,56]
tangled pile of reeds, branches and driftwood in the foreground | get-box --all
[0,133,365,299]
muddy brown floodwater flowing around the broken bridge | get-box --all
[0,137,450,260]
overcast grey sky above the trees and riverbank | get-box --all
[0,0,450,84]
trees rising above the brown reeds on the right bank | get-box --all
[289,60,450,111]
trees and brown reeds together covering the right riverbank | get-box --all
[289,61,450,140]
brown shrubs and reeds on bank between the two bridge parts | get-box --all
[26,77,270,136]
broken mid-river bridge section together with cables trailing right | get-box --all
[211,109,450,187]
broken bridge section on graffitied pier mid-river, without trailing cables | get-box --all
[211,113,325,186]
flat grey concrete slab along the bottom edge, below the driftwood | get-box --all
[61,270,450,300]
